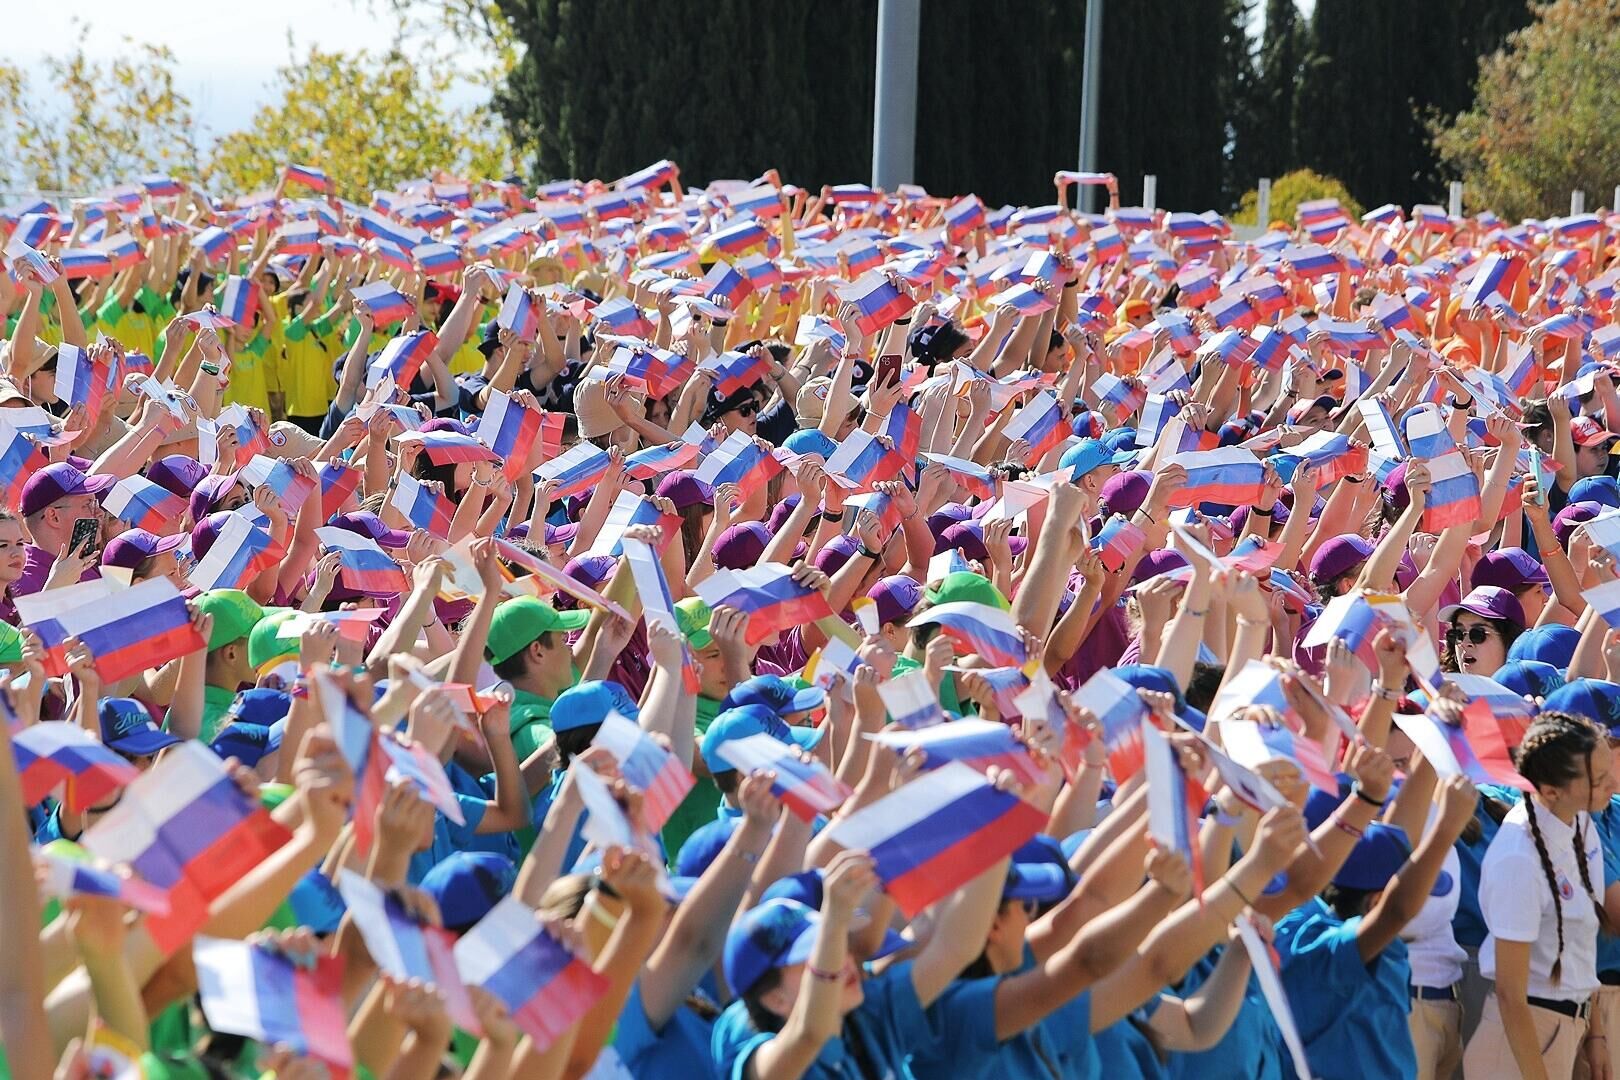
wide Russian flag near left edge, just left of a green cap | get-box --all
[16,578,206,683]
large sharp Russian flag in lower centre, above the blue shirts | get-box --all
[826,761,1047,918]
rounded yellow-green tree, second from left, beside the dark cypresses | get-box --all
[209,47,510,199]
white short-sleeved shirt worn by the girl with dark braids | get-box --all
[1479,800,1604,1001]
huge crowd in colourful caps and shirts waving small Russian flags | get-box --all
[0,162,1620,1080]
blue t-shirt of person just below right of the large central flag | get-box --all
[910,946,1102,1080]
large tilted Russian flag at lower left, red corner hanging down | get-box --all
[81,742,292,955]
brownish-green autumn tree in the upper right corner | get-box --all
[1435,0,1620,219]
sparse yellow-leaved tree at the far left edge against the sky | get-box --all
[0,28,199,191]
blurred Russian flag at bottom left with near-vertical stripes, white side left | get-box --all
[191,938,355,1075]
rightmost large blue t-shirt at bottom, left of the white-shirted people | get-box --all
[1277,897,1418,1080]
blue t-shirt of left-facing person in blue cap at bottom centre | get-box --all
[710,962,935,1080]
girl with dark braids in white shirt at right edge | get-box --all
[1463,711,1614,1080]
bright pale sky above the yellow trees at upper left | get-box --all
[0,0,495,136]
